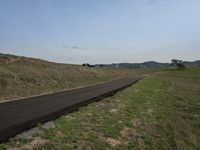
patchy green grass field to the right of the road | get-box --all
[0,68,200,150]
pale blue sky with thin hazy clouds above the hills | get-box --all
[0,0,200,64]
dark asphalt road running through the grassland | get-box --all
[0,78,140,143]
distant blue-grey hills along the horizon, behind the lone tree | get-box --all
[95,60,200,68]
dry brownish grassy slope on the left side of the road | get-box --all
[0,54,159,102]
